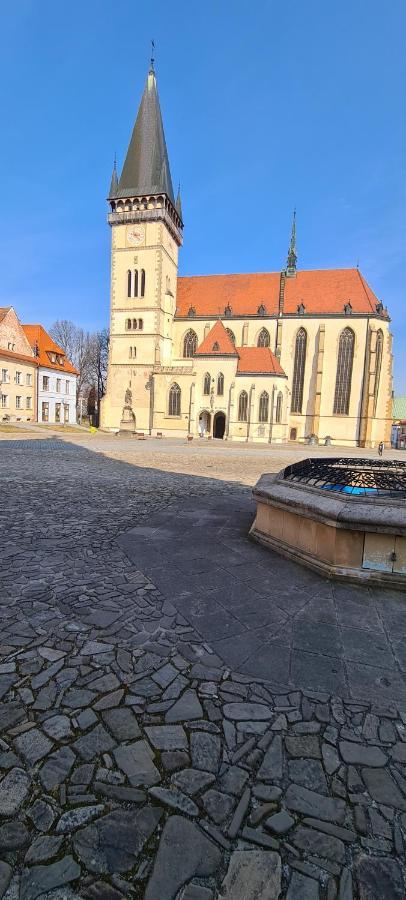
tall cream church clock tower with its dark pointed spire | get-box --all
[101,61,183,431]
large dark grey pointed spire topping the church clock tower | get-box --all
[116,67,175,204]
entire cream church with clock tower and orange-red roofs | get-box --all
[101,69,392,447]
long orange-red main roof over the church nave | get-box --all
[177,269,379,317]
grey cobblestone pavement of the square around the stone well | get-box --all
[0,440,406,900]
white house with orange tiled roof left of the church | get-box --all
[23,325,78,425]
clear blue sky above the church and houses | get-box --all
[0,0,406,393]
